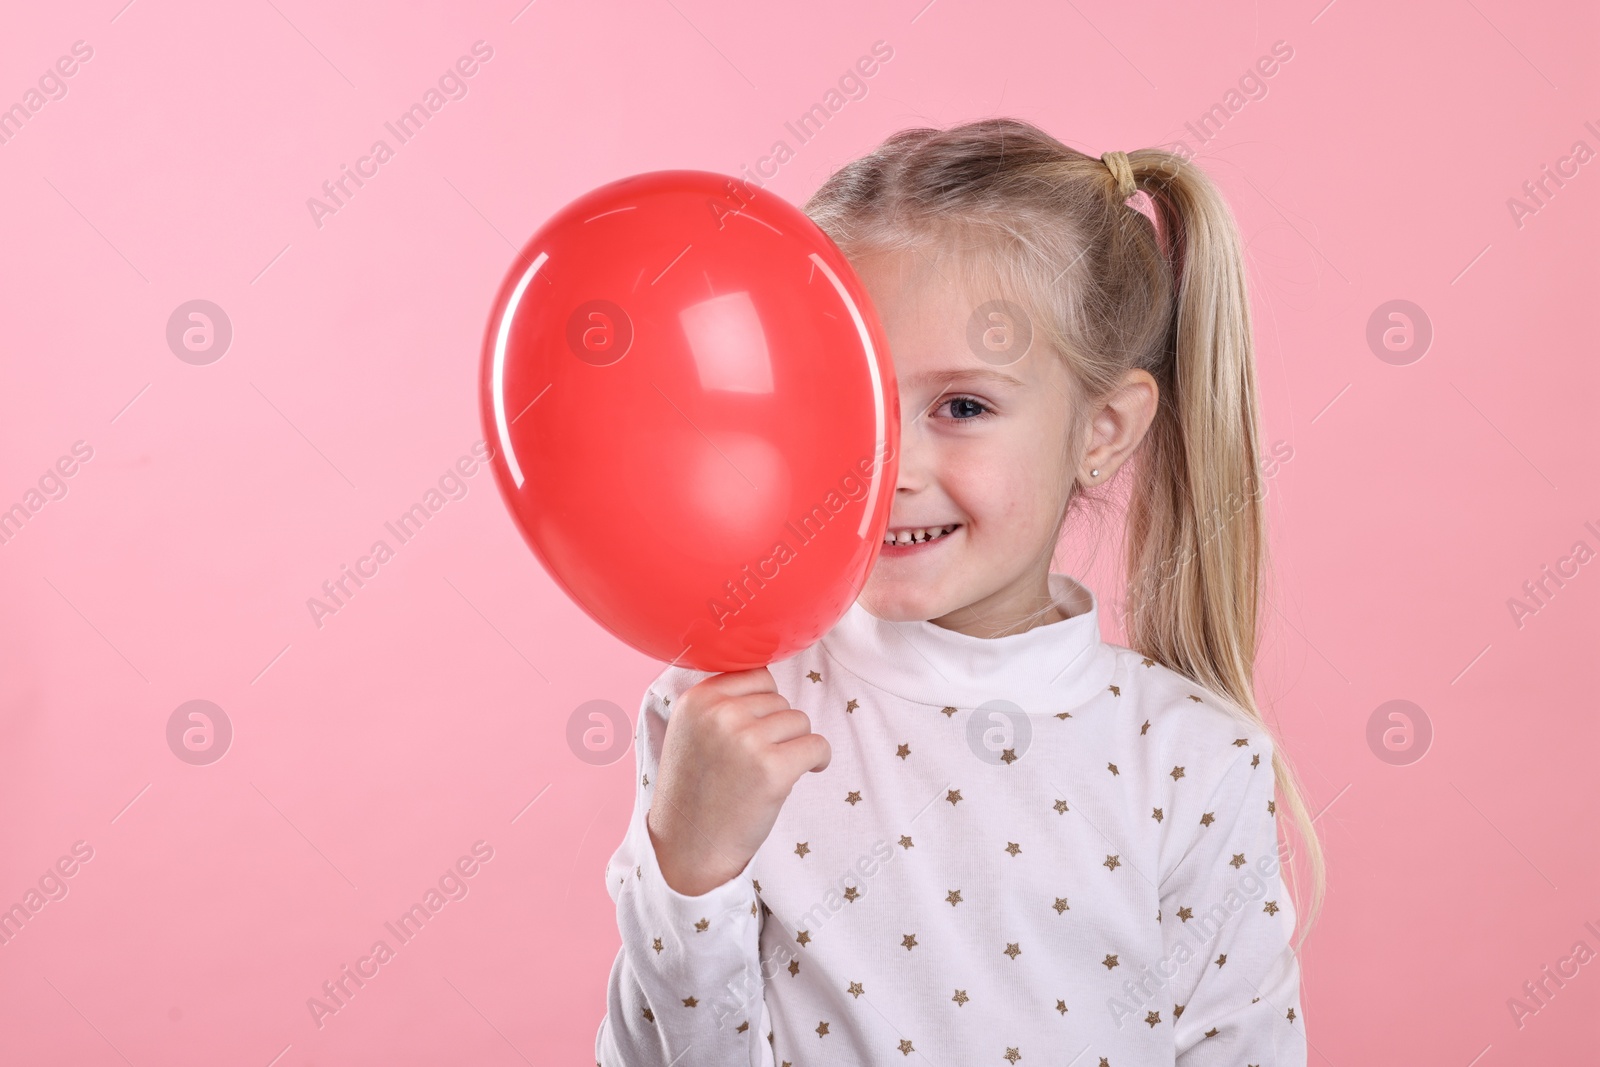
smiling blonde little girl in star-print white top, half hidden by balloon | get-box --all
[595,120,1322,1067]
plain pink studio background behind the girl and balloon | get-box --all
[0,0,1600,1067]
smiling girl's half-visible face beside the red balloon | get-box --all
[851,251,1077,637]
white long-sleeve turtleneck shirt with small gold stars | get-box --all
[595,574,1306,1067]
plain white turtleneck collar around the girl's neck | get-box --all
[821,573,1117,713]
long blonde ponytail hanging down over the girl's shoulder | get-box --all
[1123,149,1326,942]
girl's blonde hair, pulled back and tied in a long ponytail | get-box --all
[805,118,1326,949]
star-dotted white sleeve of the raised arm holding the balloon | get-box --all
[595,669,773,1067]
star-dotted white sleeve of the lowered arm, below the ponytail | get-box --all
[1160,729,1306,1067]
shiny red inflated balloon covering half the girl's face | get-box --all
[480,171,899,672]
